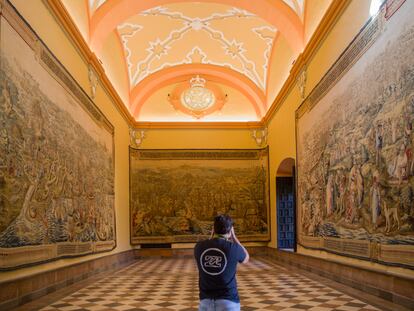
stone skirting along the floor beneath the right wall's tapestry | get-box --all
[266,248,414,310]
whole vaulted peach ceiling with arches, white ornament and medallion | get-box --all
[61,0,331,122]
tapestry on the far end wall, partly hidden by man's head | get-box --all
[129,148,269,244]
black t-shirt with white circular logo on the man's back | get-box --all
[194,238,246,302]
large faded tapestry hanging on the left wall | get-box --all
[0,2,116,270]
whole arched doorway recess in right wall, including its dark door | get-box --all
[276,158,296,251]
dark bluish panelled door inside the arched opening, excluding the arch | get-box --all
[276,177,296,251]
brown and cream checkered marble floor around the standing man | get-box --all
[25,258,394,311]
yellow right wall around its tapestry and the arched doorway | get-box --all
[268,0,414,276]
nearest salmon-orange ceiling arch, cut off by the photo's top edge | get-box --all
[90,0,304,54]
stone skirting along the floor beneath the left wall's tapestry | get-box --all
[0,250,134,310]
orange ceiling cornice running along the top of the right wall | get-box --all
[262,0,351,125]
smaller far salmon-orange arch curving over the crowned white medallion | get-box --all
[130,64,267,120]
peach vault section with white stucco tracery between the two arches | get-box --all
[118,5,277,90]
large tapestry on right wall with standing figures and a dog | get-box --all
[297,1,414,268]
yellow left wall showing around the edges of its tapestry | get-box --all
[1,0,131,280]
